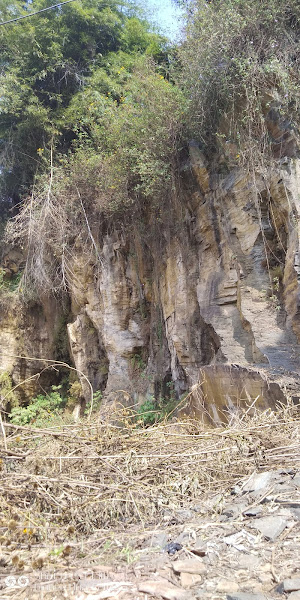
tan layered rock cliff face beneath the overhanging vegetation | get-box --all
[0,149,300,422]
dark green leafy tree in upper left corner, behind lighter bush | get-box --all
[0,0,171,201]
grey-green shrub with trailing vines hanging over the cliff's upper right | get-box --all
[180,0,300,166]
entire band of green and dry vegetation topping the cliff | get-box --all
[0,0,300,290]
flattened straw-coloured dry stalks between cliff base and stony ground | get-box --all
[0,398,300,545]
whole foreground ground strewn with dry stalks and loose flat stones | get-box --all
[0,407,300,600]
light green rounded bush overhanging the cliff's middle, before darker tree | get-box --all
[57,53,183,213]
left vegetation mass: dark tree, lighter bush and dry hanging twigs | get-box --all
[0,0,184,289]
